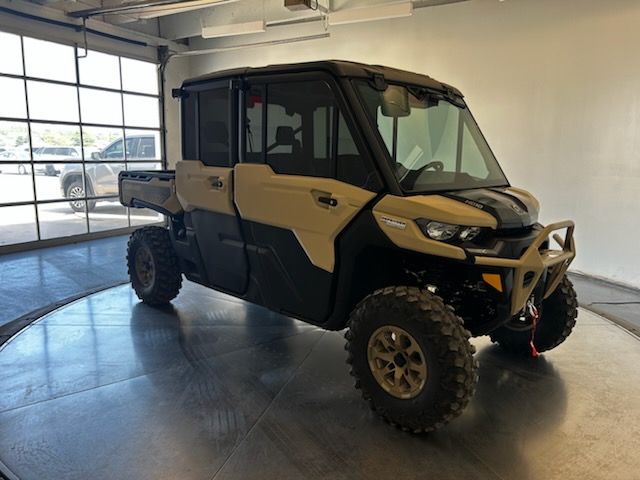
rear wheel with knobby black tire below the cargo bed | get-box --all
[127,227,182,306]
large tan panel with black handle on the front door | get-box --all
[235,163,375,272]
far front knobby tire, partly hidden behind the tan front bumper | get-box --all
[490,275,578,355]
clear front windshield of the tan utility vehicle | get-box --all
[355,80,508,193]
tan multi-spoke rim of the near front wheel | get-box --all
[367,325,427,399]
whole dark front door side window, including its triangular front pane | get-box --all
[245,80,382,191]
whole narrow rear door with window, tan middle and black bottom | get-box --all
[176,80,249,294]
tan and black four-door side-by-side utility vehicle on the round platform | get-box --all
[119,61,576,432]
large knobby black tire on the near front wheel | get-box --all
[345,286,478,433]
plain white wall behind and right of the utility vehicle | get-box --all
[191,0,640,286]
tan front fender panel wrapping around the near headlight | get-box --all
[373,195,497,260]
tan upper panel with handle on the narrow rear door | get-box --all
[176,160,236,215]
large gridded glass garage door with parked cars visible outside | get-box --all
[0,32,163,251]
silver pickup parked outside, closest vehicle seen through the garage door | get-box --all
[60,134,159,212]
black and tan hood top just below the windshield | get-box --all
[441,187,539,229]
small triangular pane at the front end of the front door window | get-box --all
[337,112,382,192]
